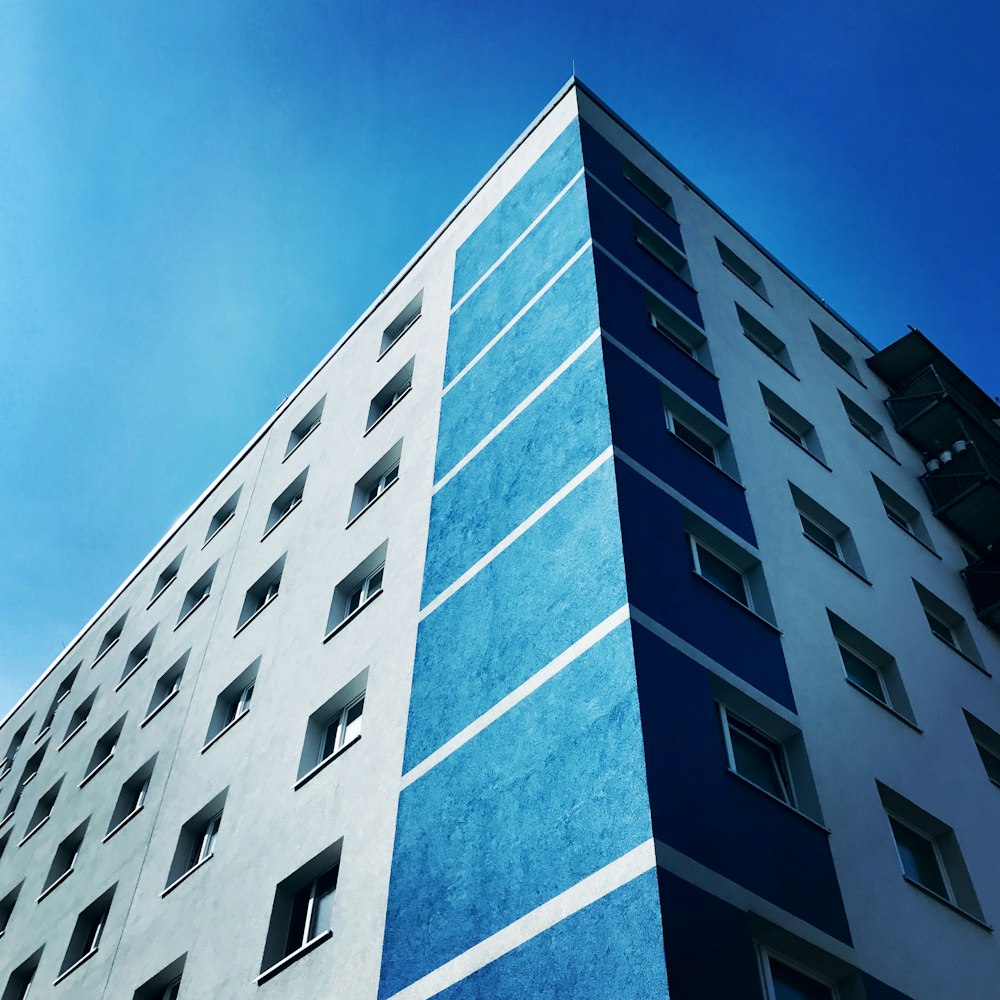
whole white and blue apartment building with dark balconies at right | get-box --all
[0,80,1000,1000]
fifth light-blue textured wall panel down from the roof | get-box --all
[403,461,625,771]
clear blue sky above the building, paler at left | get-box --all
[0,0,1000,713]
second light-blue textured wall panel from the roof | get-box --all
[444,177,590,384]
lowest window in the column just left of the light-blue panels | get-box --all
[257,841,342,983]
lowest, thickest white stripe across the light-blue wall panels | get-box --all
[384,838,656,1000]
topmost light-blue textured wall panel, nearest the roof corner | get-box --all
[452,121,583,303]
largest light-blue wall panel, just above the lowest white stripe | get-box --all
[380,624,651,997]
